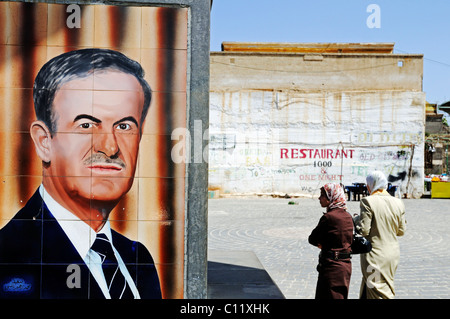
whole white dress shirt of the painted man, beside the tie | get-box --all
[39,184,140,299]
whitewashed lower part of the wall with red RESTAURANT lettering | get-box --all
[209,90,424,197]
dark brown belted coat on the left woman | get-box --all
[308,208,353,299]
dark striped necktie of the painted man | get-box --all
[91,234,134,299]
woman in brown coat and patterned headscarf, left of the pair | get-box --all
[308,183,353,299]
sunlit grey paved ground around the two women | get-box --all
[208,198,450,299]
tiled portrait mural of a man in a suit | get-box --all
[0,1,188,299]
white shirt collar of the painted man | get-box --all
[39,184,112,259]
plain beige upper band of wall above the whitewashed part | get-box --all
[210,52,423,92]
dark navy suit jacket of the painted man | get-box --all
[0,191,161,299]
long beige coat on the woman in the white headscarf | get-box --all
[360,191,406,299]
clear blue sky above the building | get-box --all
[211,0,450,104]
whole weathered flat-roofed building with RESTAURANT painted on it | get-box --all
[209,42,426,197]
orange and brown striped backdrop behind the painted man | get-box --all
[0,1,188,298]
